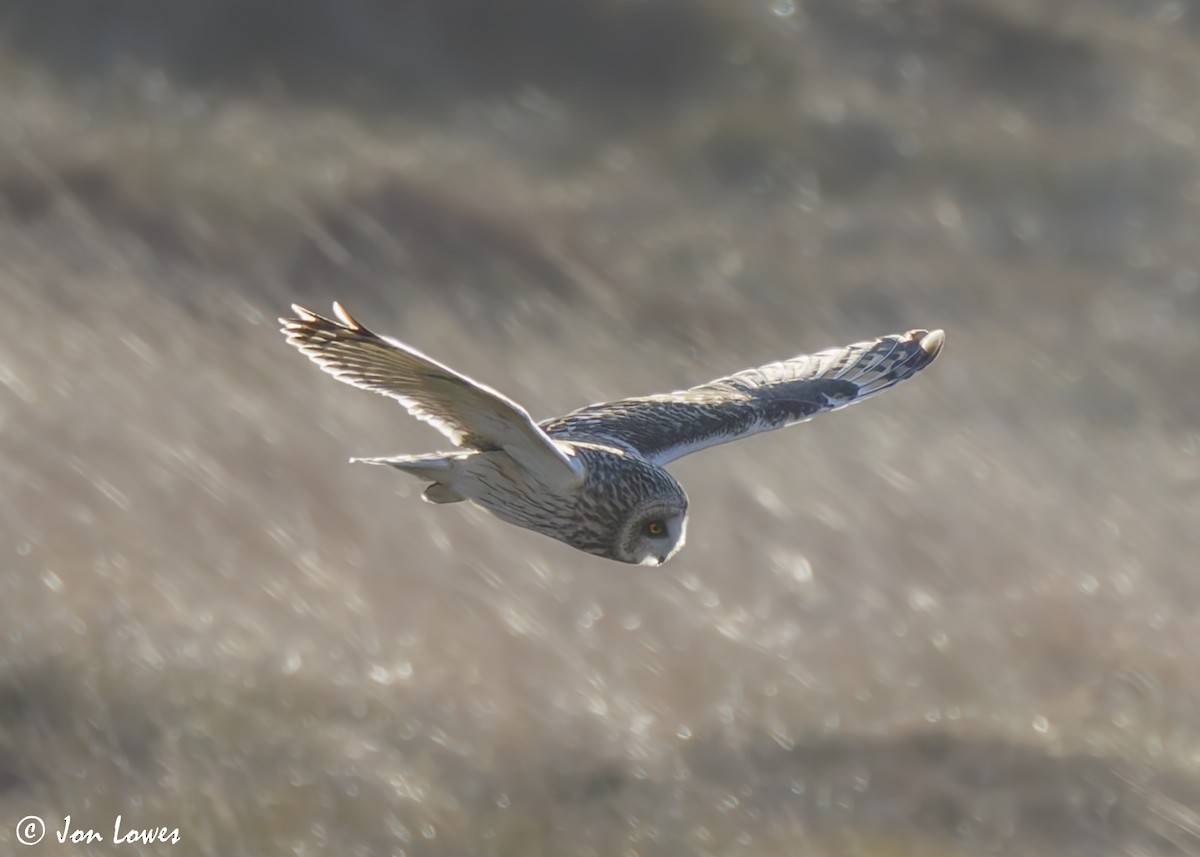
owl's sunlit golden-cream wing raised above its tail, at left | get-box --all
[280,302,583,490]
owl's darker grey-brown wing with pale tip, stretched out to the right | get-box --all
[541,330,946,465]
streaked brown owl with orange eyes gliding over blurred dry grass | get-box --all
[280,304,946,565]
